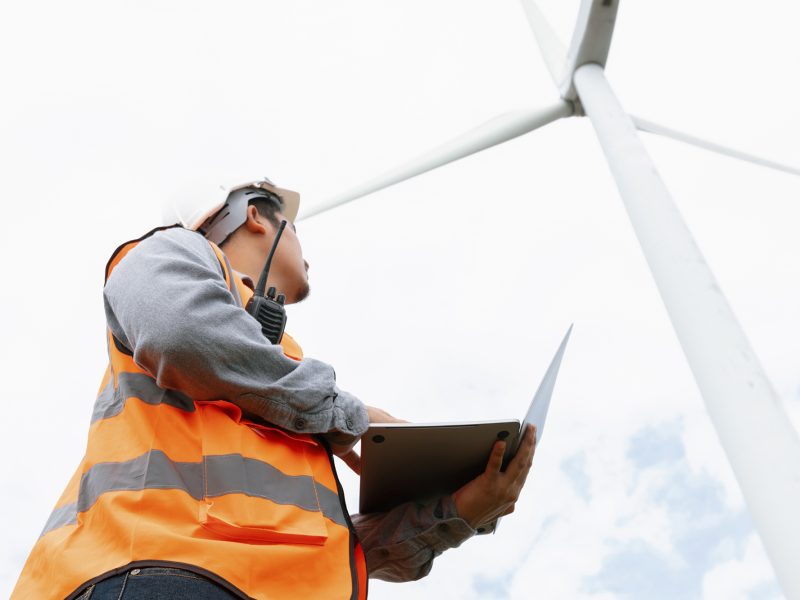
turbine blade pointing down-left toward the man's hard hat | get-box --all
[300,100,574,219]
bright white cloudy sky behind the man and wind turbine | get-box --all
[0,0,800,600]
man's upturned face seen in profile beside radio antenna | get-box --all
[259,213,310,304]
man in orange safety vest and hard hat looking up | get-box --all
[12,179,534,600]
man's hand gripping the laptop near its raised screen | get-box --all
[453,425,536,529]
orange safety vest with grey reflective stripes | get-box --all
[12,230,367,600]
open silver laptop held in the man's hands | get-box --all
[359,326,572,533]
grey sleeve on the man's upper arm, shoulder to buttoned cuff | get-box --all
[103,228,368,436]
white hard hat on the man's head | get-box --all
[163,177,300,244]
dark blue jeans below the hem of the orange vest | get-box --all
[75,567,239,600]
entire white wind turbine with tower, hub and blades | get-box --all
[300,0,800,599]
